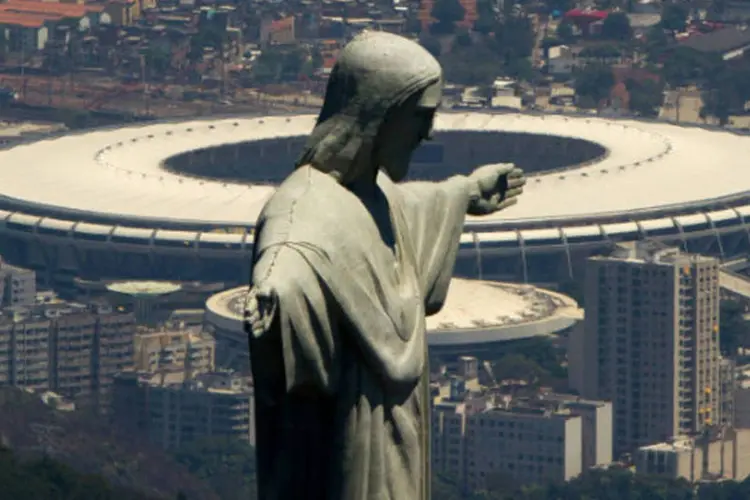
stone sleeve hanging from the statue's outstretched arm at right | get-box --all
[399,176,469,316]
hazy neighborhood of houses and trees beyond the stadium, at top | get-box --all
[0,0,750,128]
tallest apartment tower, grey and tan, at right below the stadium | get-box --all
[569,241,722,456]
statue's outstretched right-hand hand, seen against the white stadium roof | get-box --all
[467,163,526,215]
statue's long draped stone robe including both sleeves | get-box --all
[250,166,469,500]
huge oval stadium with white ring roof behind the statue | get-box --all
[0,112,750,287]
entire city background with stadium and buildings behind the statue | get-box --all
[0,0,750,500]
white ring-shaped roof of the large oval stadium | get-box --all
[0,113,750,225]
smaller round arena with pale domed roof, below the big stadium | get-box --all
[205,278,582,368]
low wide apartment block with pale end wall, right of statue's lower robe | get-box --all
[432,389,612,491]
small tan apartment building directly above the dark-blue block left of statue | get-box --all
[135,327,216,374]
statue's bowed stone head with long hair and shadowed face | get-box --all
[297,32,442,184]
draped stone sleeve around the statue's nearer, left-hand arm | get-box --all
[250,245,338,395]
